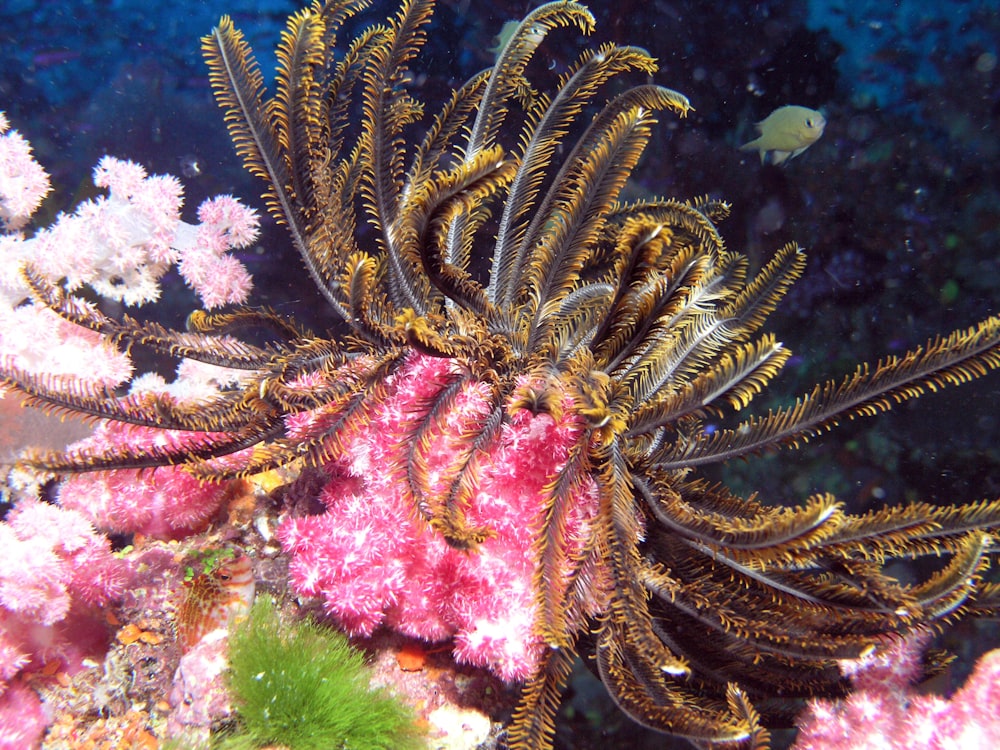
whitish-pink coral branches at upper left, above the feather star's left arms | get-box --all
[0,113,259,307]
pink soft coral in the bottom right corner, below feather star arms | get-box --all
[792,633,1000,750]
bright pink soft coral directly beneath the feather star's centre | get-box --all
[278,355,602,680]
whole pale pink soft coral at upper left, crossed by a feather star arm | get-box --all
[0,114,259,394]
